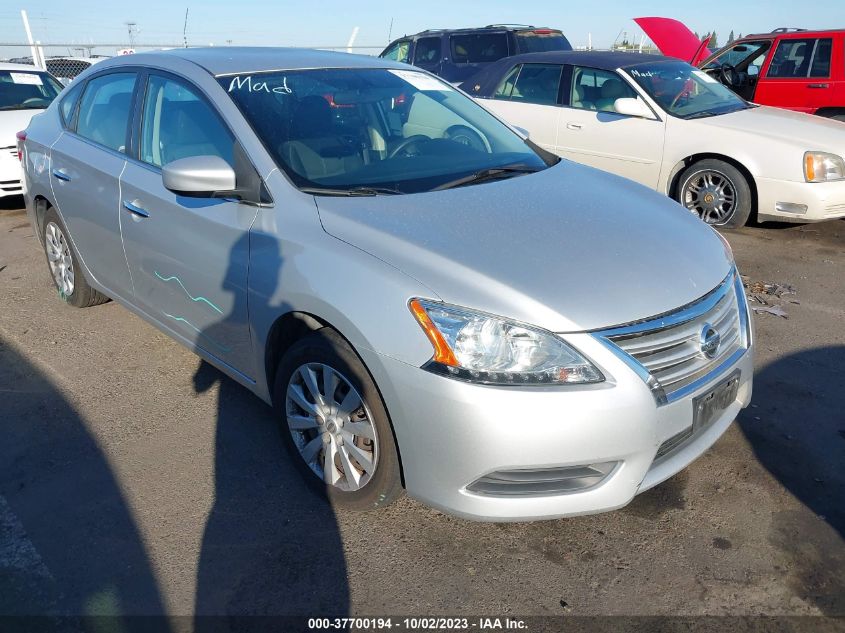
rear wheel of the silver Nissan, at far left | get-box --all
[41,208,109,308]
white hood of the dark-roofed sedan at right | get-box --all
[691,106,845,156]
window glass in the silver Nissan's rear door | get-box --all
[76,73,137,152]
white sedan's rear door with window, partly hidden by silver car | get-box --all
[484,64,563,153]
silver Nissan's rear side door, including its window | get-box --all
[51,71,138,298]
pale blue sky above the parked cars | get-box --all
[0,0,845,57]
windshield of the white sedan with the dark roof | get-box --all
[625,62,751,119]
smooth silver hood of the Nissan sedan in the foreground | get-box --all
[317,161,732,332]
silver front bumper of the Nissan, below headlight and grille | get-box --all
[362,334,753,521]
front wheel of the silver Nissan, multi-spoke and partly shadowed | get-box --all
[273,328,403,511]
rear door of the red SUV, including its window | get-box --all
[754,37,834,113]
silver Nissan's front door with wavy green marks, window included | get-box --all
[120,73,256,378]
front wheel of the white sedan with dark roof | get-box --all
[675,158,752,229]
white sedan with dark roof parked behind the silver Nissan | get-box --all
[461,52,845,228]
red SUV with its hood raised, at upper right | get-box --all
[636,18,845,121]
